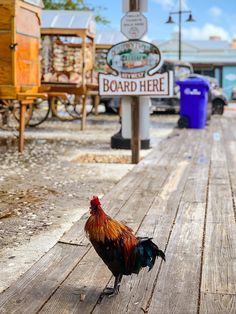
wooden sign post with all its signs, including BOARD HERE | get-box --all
[99,0,174,163]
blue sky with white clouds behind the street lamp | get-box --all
[88,0,236,41]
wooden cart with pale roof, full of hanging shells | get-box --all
[41,10,98,130]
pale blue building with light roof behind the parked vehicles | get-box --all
[153,36,236,100]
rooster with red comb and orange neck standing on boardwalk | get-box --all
[84,196,165,296]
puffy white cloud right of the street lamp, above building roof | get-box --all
[180,23,230,40]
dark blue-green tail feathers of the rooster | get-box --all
[135,238,166,273]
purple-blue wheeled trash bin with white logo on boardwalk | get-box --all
[176,76,210,129]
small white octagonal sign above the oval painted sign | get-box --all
[121,12,147,39]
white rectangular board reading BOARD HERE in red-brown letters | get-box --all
[99,72,174,97]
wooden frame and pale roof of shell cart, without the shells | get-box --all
[41,10,98,130]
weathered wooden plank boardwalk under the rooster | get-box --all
[0,117,236,314]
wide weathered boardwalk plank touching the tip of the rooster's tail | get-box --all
[146,133,210,314]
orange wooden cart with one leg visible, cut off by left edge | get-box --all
[0,0,47,151]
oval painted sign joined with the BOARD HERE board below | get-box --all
[99,40,173,97]
